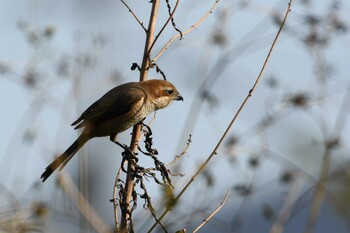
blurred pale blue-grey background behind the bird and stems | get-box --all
[0,0,350,232]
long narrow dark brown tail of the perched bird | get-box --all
[40,133,90,182]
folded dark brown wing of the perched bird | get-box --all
[72,85,145,129]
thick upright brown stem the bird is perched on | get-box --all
[120,0,160,233]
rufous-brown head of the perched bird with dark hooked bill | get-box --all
[143,79,183,109]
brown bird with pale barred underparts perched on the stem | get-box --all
[41,80,183,182]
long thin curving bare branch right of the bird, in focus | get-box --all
[148,0,293,232]
